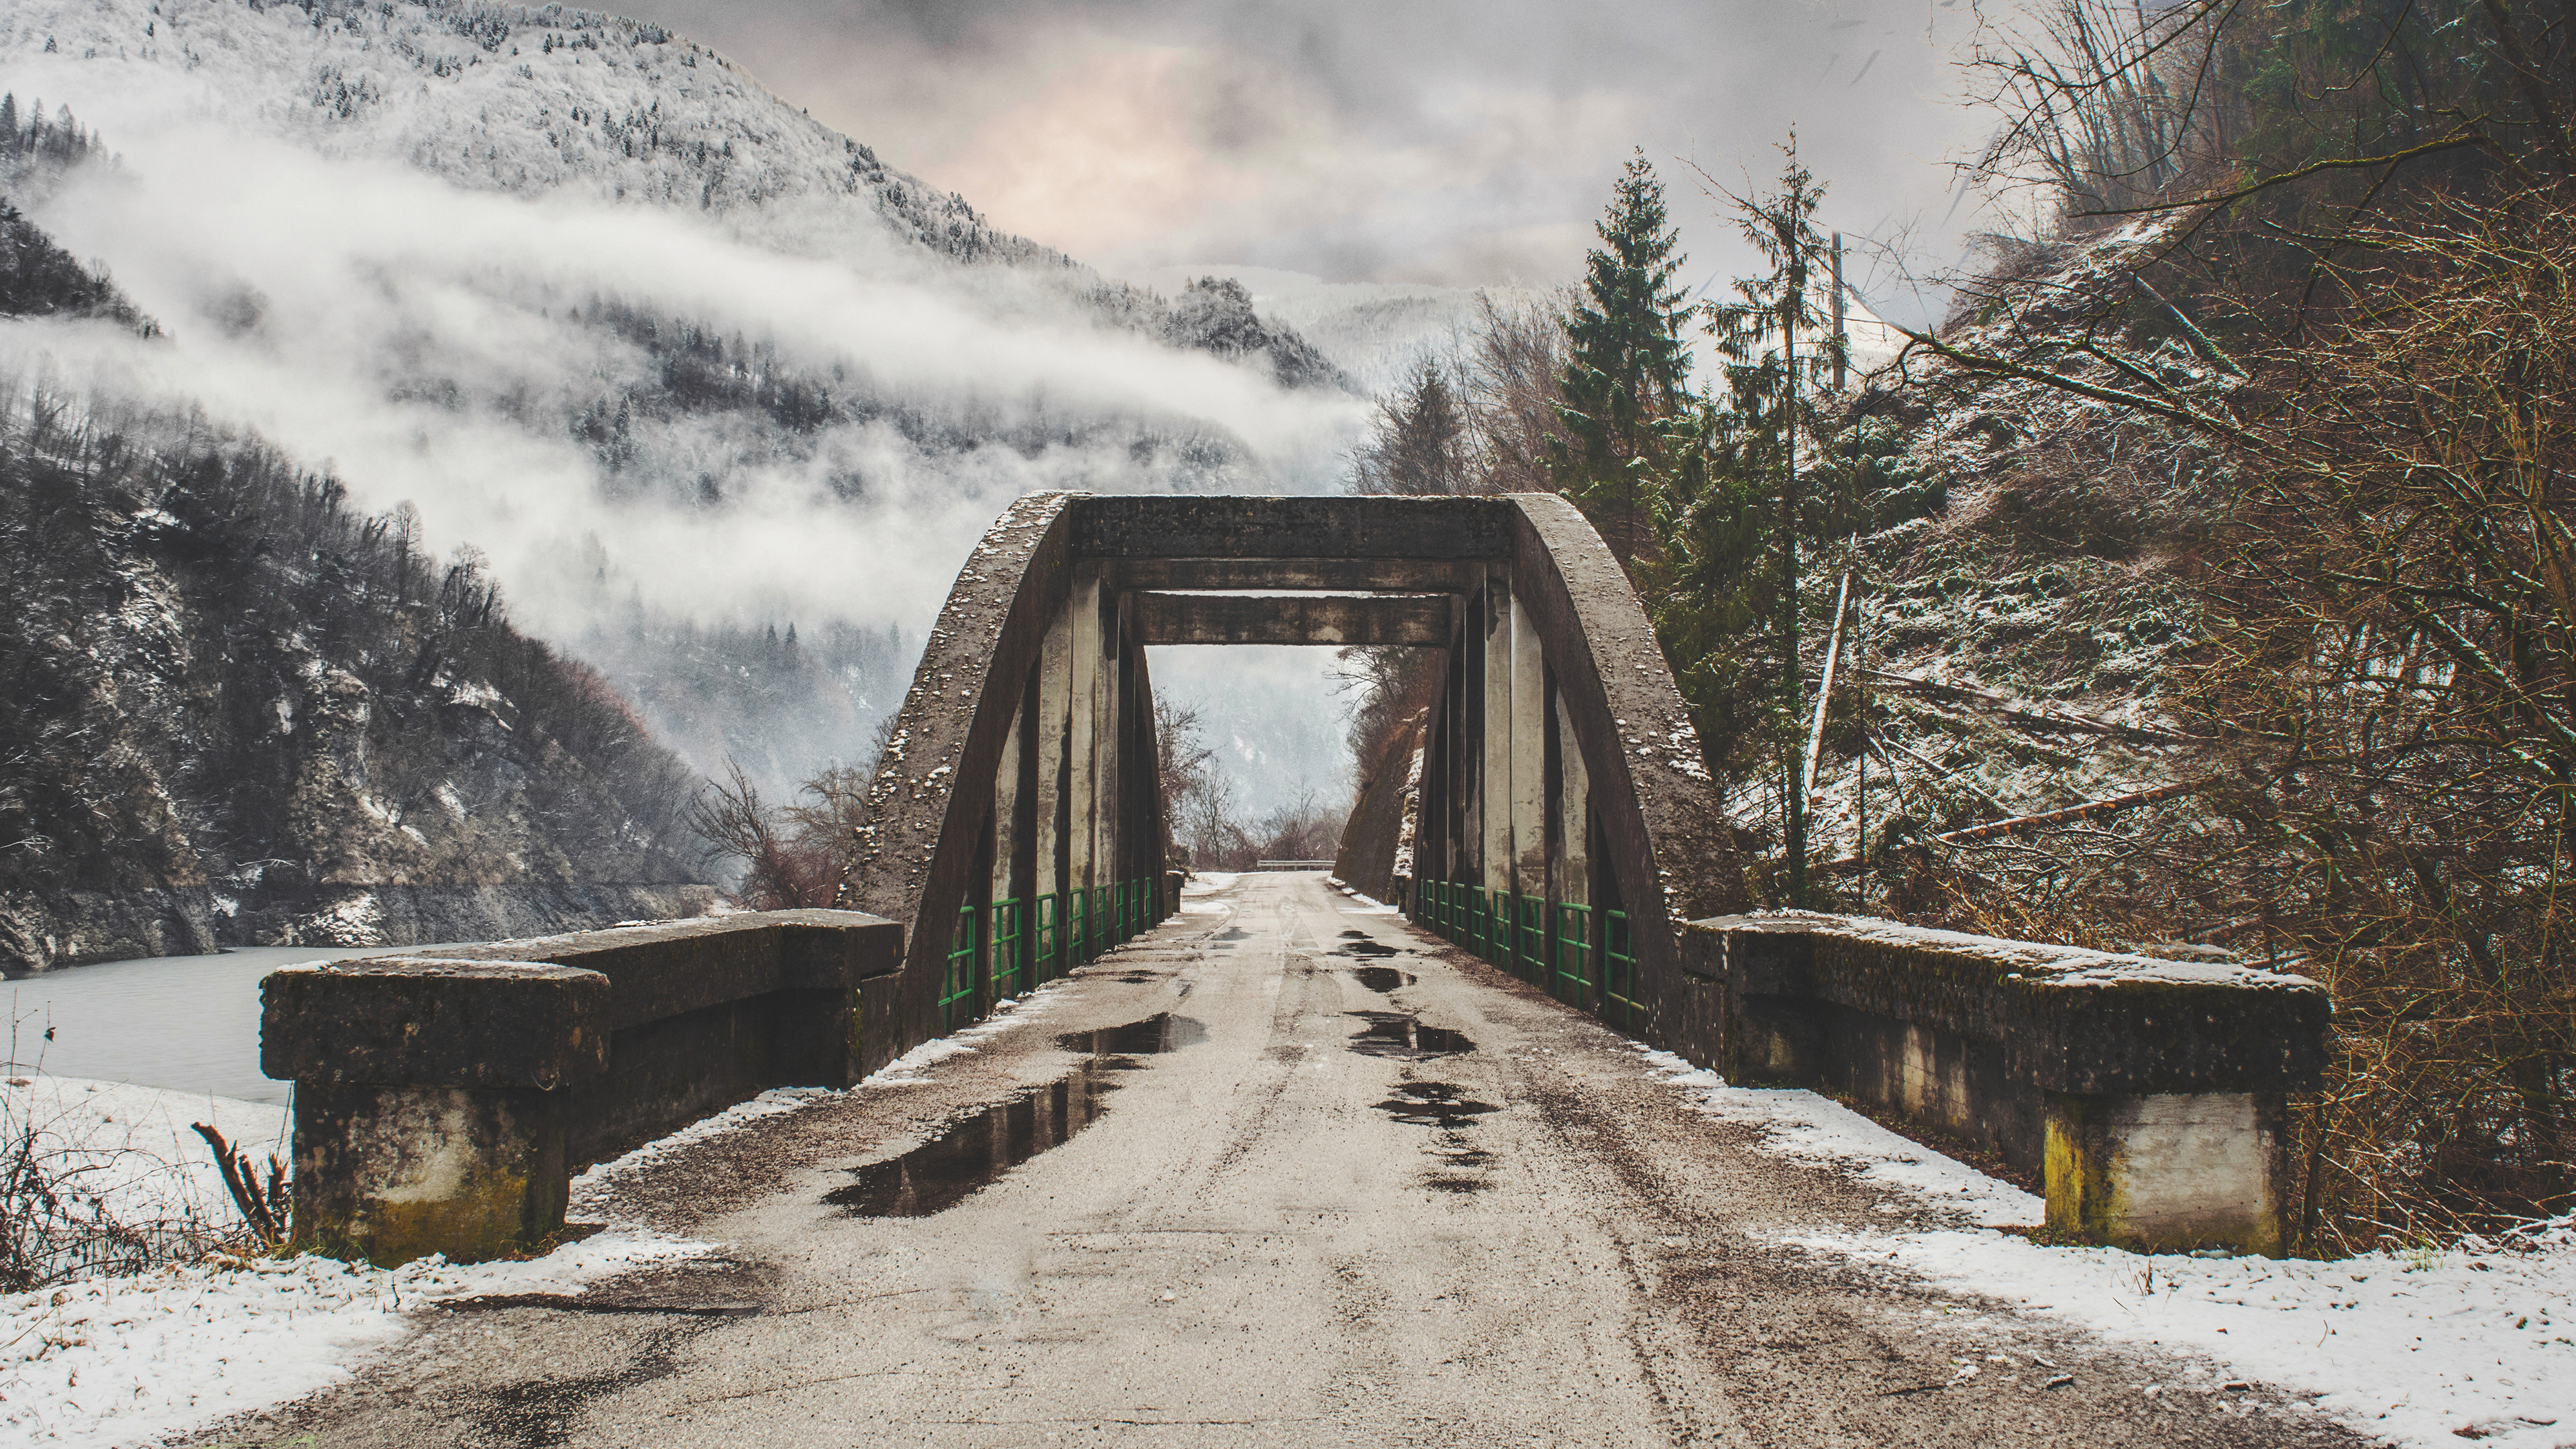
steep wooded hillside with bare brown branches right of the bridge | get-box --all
[1358,0,2576,1253]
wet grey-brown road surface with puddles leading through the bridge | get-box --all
[206,874,2359,1449]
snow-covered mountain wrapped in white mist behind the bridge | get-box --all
[0,0,1365,792]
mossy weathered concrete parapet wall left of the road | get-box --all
[260,910,904,1263]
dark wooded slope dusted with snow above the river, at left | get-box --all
[0,379,708,969]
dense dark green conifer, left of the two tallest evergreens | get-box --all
[1548,152,1690,578]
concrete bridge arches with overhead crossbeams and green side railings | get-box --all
[840,492,1747,1067]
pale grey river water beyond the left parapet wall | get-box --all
[0,947,466,1106]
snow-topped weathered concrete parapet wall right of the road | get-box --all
[1682,913,2331,1253]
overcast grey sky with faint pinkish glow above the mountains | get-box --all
[613,0,1978,321]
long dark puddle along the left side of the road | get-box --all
[822,1011,1208,1217]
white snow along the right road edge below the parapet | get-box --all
[1638,1046,2576,1449]
